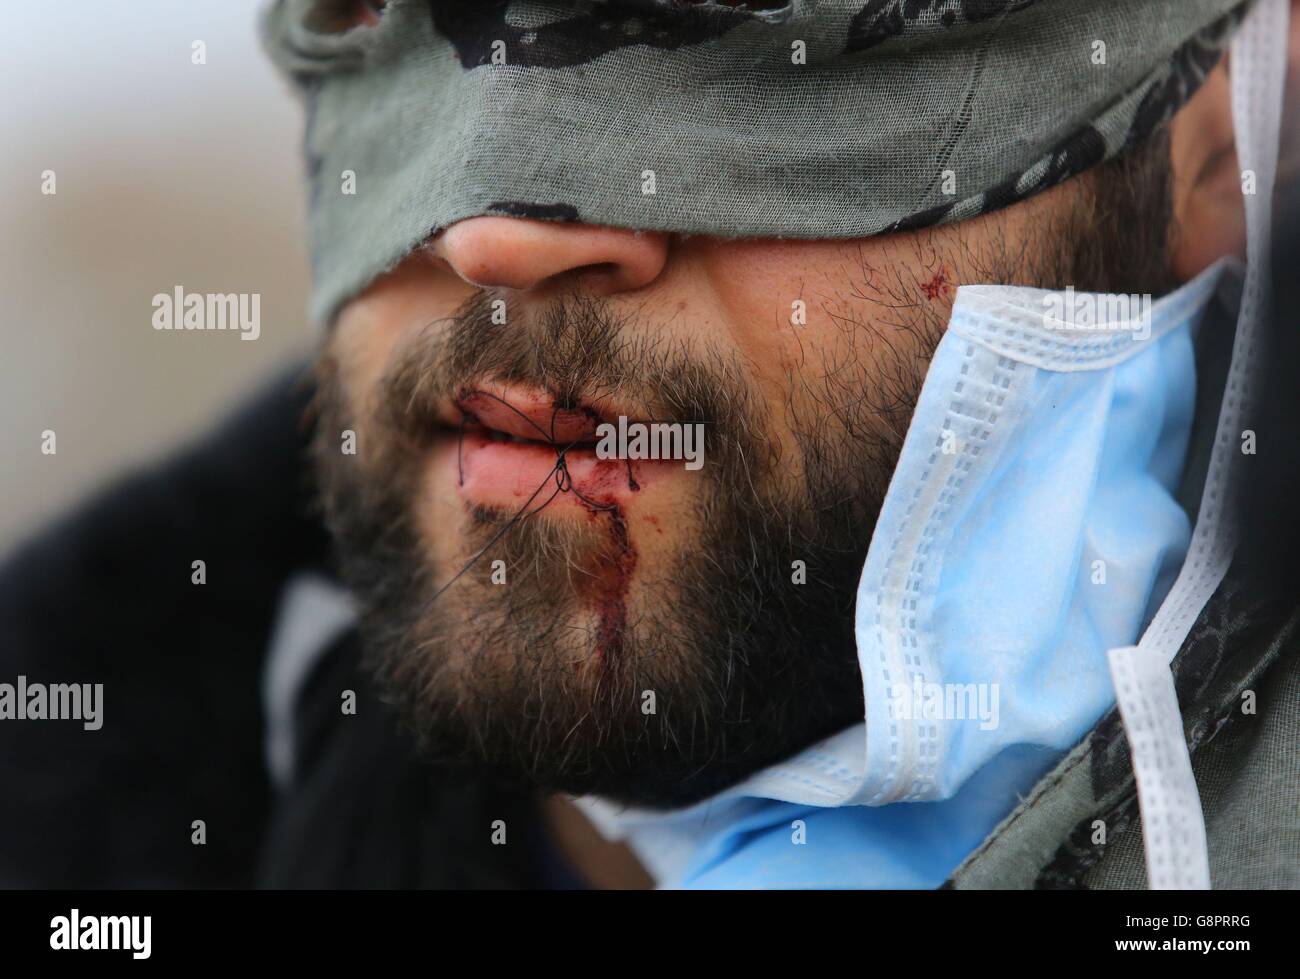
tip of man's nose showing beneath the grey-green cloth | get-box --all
[430,217,668,295]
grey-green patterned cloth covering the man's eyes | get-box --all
[264,0,1251,321]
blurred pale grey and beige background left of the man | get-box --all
[0,0,313,551]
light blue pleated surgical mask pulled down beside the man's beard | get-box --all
[580,263,1226,887]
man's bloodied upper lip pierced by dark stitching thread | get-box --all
[449,384,610,445]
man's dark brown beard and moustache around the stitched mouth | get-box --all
[313,131,1171,807]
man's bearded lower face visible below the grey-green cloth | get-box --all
[317,158,1170,806]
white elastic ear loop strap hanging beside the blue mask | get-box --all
[1109,0,1288,889]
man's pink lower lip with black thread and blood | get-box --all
[437,432,665,508]
